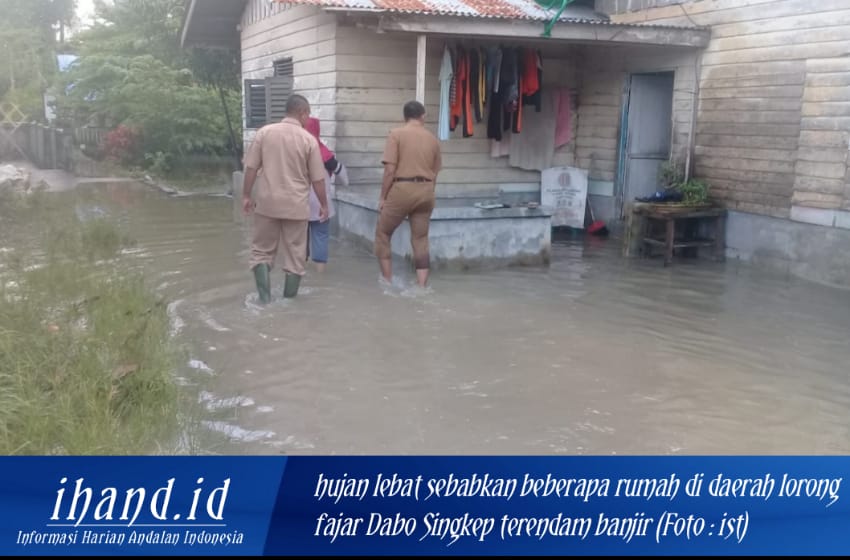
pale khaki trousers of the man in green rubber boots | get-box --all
[251,213,308,276]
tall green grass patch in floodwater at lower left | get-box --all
[0,190,186,455]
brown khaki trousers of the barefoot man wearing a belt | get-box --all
[375,183,435,270]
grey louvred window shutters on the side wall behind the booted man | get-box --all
[244,58,294,128]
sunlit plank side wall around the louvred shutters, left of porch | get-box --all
[242,0,337,147]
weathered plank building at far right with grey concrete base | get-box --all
[597,0,850,286]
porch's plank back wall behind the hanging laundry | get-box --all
[333,26,577,200]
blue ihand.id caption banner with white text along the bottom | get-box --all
[0,457,850,556]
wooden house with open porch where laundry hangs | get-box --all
[183,0,711,270]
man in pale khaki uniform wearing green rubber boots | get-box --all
[242,95,328,303]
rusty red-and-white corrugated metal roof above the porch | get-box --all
[276,0,608,23]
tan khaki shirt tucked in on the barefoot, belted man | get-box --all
[381,121,443,181]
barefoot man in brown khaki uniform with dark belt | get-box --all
[375,101,442,287]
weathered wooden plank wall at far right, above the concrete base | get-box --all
[599,0,850,218]
